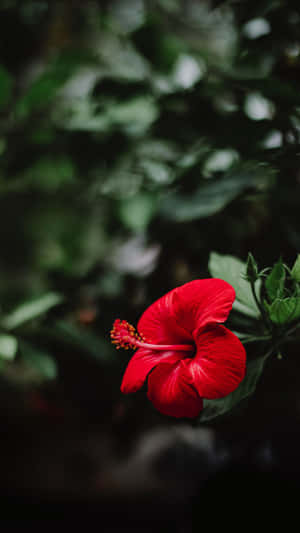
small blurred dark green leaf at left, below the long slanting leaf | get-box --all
[20,342,57,379]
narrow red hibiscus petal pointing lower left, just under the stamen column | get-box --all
[121,348,186,394]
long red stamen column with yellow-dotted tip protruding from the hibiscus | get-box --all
[110,318,194,352]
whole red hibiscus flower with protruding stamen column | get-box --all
[111,279,246,418]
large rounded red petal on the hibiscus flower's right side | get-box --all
[183,325,246,400]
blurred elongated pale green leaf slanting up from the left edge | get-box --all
[1,292,62,329]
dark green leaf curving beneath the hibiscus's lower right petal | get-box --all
[199,356,266,422]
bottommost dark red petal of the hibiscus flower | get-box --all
[148,361,203,418]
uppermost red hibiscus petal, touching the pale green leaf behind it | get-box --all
[171,278,235,334]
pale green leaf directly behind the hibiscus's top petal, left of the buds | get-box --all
[208,252,261,317]
